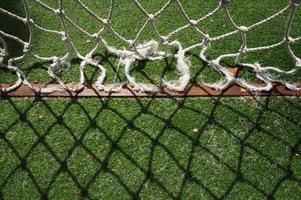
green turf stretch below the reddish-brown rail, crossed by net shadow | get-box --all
[0,97,301,199]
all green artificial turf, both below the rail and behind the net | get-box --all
[0,0,301,200]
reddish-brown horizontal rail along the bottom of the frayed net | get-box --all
[0,83,301,98]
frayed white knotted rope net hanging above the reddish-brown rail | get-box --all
[0,0,301,93]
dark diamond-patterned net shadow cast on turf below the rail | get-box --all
[0,94,301,199]
